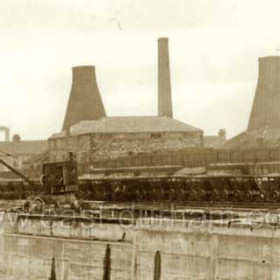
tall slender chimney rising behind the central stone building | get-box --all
[158,38,173,118]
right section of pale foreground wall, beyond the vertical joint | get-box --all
[136,219,280,280]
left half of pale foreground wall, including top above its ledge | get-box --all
[0,214,135,280]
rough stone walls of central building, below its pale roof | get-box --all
[49,132,203,170]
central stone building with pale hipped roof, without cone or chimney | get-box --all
[49,116,202,162]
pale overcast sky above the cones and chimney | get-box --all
[0,0,280,139]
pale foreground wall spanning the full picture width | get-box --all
[0,213,280,280]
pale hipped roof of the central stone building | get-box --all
[53,116,202,137]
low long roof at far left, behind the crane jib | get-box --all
[0,140,48,155]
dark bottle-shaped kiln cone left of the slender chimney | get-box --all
[63,66,106,130]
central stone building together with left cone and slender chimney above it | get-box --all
[49,38,203,166]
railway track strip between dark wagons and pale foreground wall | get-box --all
[86,202,280,225]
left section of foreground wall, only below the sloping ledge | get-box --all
[0,235,133,280]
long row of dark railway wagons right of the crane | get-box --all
[79,176,280,203]
